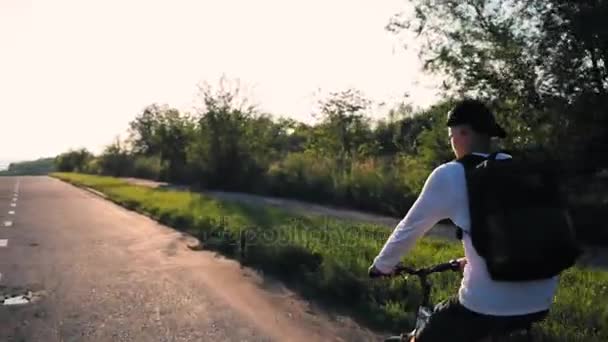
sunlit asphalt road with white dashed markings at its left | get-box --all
[0,177,377,342]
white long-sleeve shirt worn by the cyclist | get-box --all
[374,153,558,316]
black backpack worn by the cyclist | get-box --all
[457,152,581,281]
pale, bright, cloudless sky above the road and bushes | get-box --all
[0,0,438,160]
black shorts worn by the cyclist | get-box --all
[416,297,549,342]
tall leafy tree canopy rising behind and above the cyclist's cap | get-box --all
[387,0,608,168]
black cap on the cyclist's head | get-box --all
[447,99,507,138]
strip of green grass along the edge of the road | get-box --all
[53,173,608,342]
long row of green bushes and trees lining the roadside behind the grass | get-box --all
[54,79,608,241]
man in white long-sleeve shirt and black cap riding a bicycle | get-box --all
[369,99,557,342]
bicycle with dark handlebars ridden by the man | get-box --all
[376,259,533,342]
